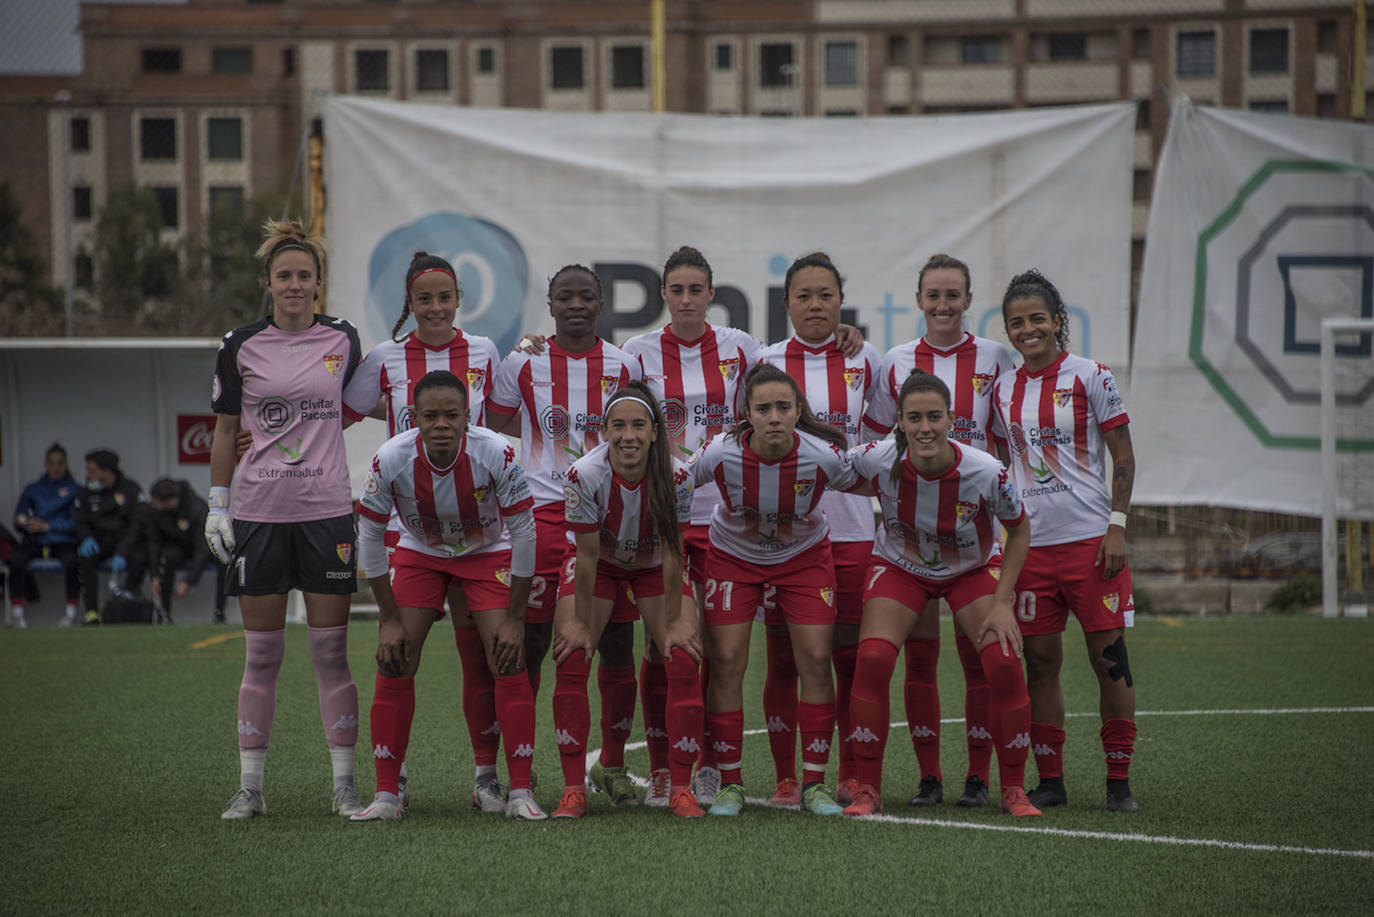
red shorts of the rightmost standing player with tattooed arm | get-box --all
[1015,536,1135,637]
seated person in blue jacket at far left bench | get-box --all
[10,443,81,627]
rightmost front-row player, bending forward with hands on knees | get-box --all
[845,370,1040,815]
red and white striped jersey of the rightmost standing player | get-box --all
[992,353,1131,547]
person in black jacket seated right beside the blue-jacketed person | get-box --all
[77,450,148,624]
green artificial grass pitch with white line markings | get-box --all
[0,617,1374,916]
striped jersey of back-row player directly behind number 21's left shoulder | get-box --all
[758,335,881,542]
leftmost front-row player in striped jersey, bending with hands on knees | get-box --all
[353,370,547,822]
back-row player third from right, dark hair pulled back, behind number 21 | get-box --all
[760,252,878,806]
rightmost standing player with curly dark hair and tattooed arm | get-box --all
[992,271,1139,813]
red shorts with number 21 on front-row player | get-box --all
[705,539,835,626]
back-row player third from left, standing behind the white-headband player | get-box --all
[488,264,640,803]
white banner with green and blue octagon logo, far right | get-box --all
[1129,96,1374,518]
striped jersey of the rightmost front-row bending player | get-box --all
[853,440,1025,580]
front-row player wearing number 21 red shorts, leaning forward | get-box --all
[692,364,859,815]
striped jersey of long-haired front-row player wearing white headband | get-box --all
[563,443,694,571]
